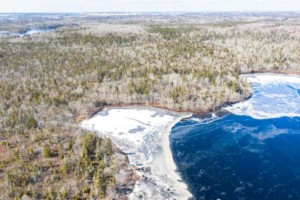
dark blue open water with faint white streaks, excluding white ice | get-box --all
[170,74,300,200]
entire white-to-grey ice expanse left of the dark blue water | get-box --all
[82,107,191,200]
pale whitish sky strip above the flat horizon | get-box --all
[0,0,300,13]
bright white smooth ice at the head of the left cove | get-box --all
[82,108,175,146]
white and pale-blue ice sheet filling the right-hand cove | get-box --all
[224,74,300,119]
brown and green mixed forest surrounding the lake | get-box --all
[0,13,300,199]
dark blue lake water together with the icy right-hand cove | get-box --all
[170,74,300,200]
